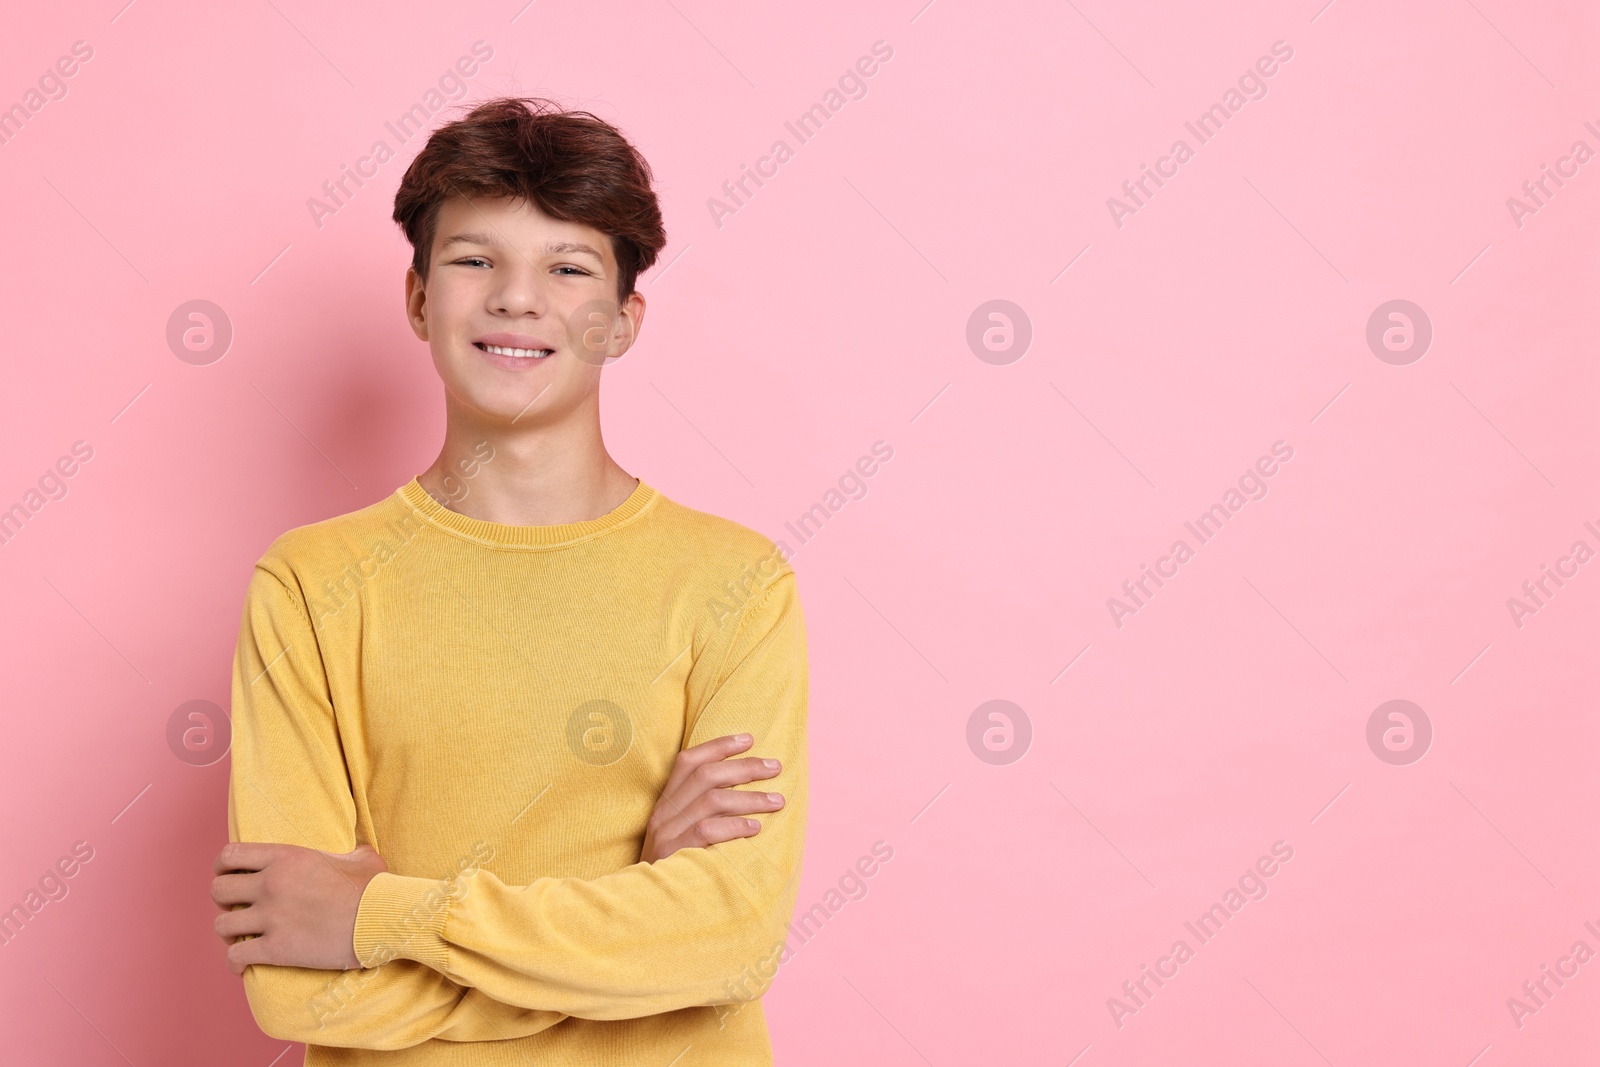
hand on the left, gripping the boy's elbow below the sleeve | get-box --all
[211,841,389,974]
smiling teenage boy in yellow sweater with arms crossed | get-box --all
[211,99,808,1067]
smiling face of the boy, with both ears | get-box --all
[405,198,645,426]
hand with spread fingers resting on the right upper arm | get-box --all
[638,734,784,864]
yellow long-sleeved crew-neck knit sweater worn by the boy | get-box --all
[229,480,808,1067]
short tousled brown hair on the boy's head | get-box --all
[394,96,667,301]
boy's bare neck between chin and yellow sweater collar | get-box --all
[418,391,638,526]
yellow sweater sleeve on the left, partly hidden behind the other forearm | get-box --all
[227,565,565,1049]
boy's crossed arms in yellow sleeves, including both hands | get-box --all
[213,568,806,1049]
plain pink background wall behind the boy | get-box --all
[0,0,1600,1067]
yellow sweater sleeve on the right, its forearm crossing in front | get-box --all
[344,566,808,1019]
